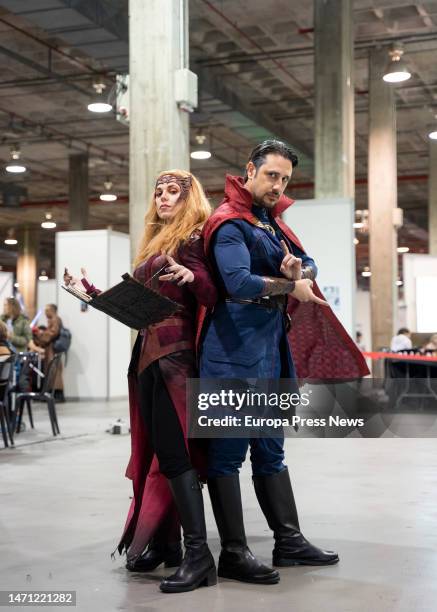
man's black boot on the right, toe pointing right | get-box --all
[253,468,339,567]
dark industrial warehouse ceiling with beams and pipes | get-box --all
[0,0,437,280]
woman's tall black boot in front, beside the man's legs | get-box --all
[160,470,217,593]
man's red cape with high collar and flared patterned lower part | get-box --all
[203,175,369,380]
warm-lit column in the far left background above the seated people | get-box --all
[17,228,39,319]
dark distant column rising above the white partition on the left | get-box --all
[68,153,89,230]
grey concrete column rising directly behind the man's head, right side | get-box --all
[314,0,355,199]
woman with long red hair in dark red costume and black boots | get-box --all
[64,170,217,592]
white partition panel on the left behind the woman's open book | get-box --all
[56,230,130,399]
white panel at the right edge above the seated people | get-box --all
[403,253,437,333]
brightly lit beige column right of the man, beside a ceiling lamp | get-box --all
[368,47,398,350]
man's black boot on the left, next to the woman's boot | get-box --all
[208,473,279,584]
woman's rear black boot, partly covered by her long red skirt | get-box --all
[126,506,182,572]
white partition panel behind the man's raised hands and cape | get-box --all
[283,199,356,338]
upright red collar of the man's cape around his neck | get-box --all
[203,174,303,253]
